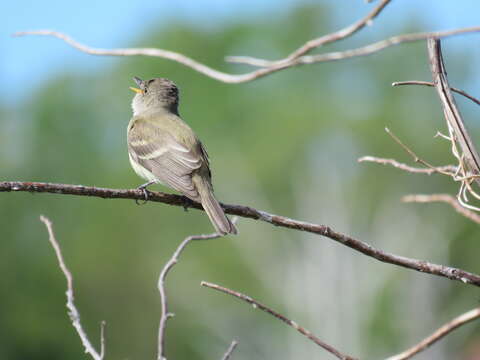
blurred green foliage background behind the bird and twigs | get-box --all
[0,6,480,360]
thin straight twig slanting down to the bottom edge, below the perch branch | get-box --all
[200,281,354,360]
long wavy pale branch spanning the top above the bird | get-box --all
[13,25,480,84]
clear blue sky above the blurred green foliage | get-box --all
[0,0,480,104]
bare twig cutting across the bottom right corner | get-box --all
[387,307,480,360]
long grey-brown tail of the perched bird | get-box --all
[196,176,238,235]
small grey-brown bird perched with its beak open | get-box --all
[127,76,237,235]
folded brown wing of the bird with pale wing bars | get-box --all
[128,118,203,200]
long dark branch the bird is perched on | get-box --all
[0,181,480,286]
